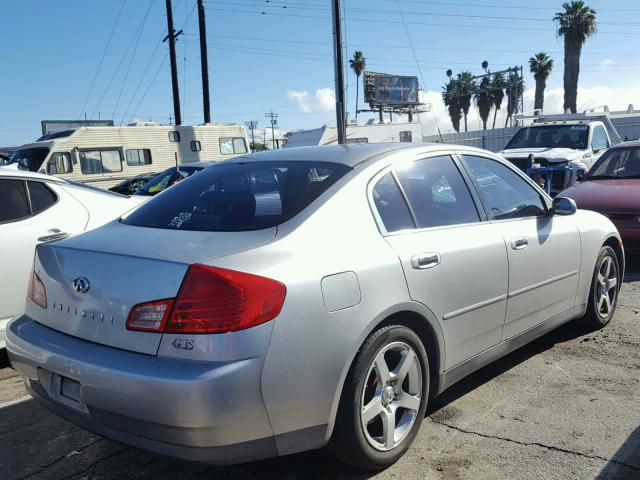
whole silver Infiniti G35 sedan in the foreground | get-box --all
[7,144,624,470]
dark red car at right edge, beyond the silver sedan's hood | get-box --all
[560,141,640,253]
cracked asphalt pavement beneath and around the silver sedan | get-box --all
[0,267,640,480]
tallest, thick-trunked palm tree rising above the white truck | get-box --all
[553,1,596,113]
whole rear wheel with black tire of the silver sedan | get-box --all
[328,325,430,470]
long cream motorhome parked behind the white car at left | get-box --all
[5,122,249,188]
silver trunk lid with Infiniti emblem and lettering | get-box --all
[27,223,275,355]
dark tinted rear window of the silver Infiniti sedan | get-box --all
[122,162,349,232]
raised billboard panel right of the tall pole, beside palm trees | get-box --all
[363,71,420,106]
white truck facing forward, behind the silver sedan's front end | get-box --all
[499,114,620,195]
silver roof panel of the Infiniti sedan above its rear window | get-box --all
[224,142,450,167]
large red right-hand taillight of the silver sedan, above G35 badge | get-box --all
[127,264,286,333]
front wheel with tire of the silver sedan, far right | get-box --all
[582,246,622,330]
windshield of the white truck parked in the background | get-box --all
[505,125,589,150]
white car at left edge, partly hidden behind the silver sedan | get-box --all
[0,169,140,349]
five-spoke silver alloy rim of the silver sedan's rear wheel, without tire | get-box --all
[360,342,423,451]
